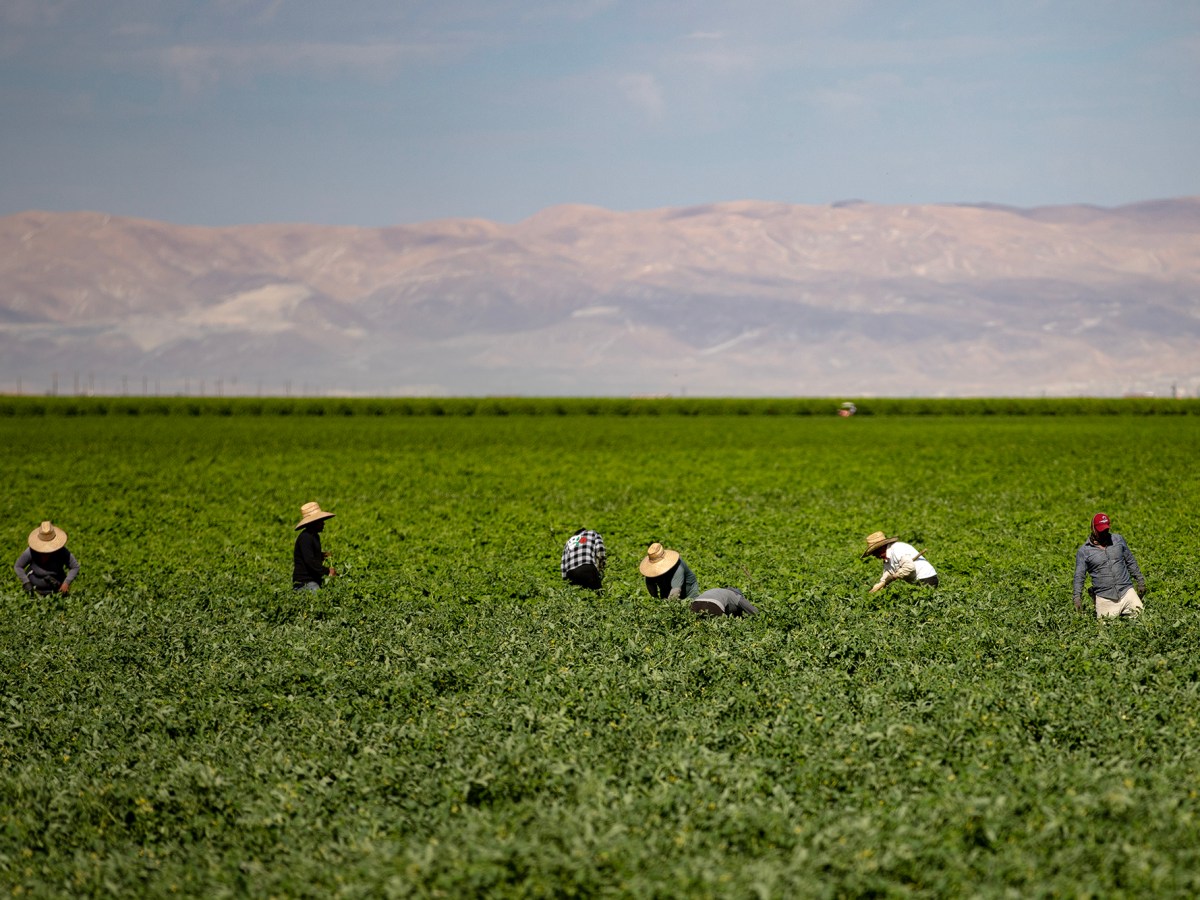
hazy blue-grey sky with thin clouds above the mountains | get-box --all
[0,0,1200,226]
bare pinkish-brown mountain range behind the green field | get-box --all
[0,198,1200,396]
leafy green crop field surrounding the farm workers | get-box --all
[0,401,1200,898]
